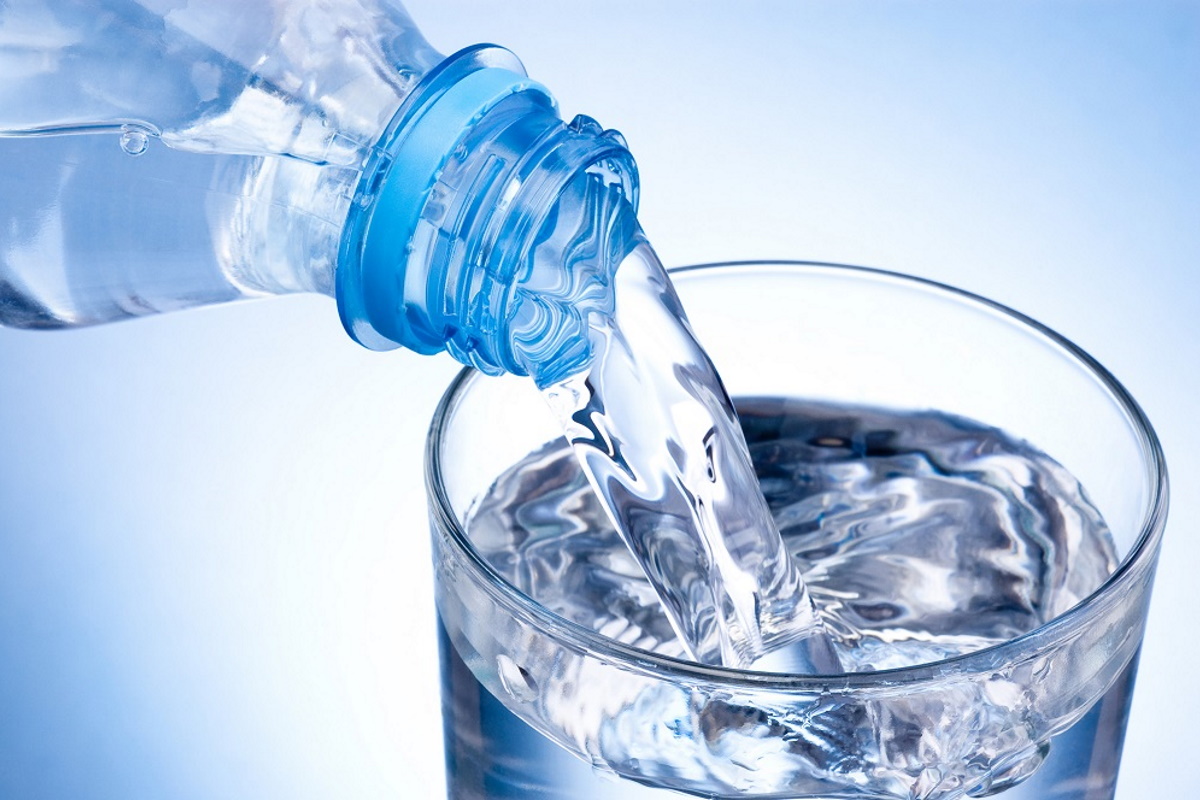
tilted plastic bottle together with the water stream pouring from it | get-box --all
[0,0,835,672]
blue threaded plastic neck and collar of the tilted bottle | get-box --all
[336,48,637,374]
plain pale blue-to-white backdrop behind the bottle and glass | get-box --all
[0,0,1200,800]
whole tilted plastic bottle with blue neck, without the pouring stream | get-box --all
[0,0,637,373]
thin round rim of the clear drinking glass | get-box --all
[425,260,1169,692]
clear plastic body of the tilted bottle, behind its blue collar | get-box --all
[0,0,442,327]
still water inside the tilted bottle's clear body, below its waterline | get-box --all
[0,127,356,327]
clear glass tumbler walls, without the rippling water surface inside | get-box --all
[427,263,1166,800]
